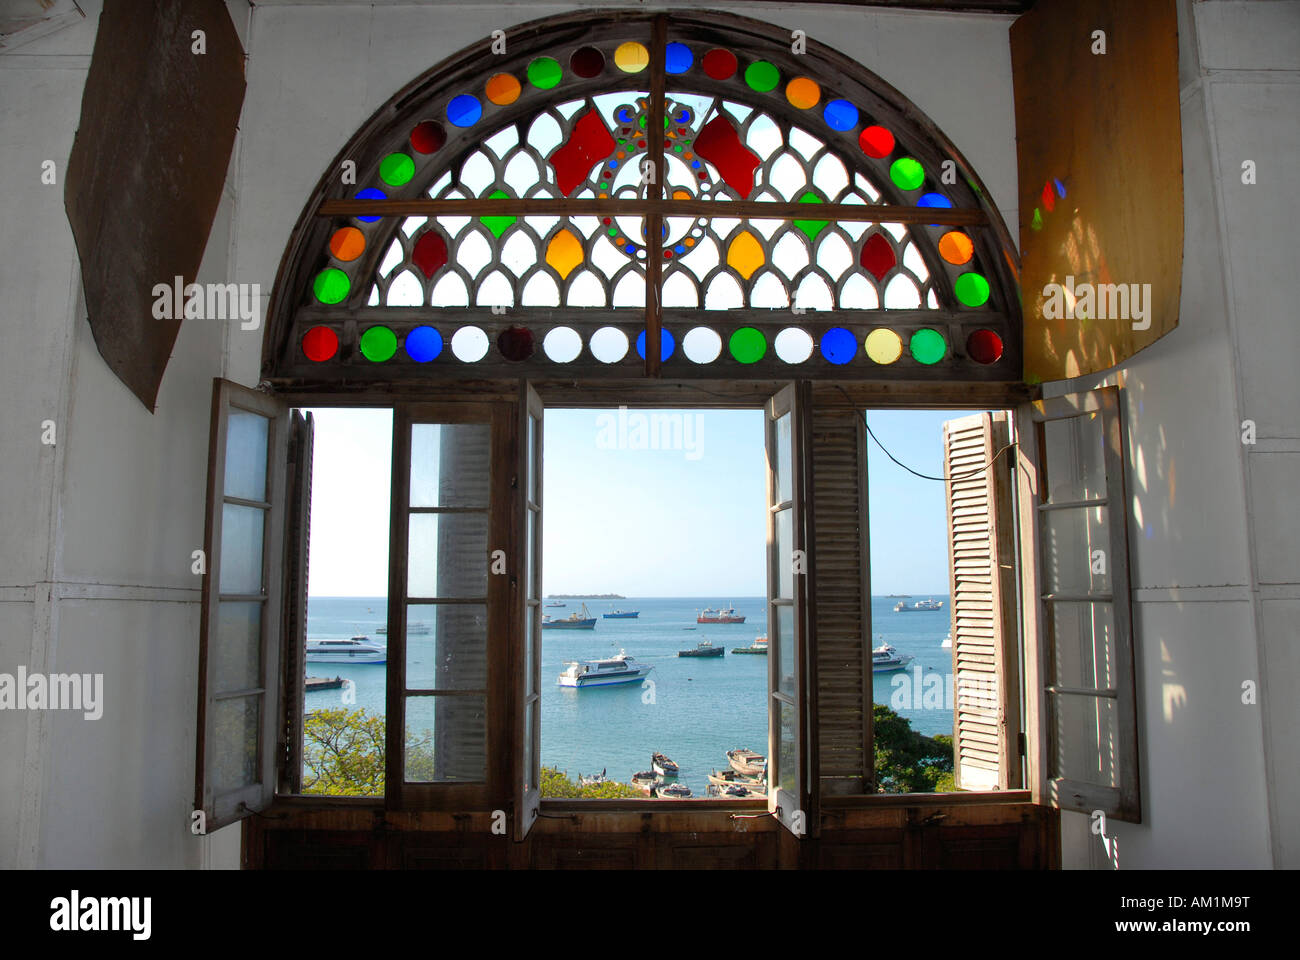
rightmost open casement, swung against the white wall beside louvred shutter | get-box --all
[1017,386,1141,822]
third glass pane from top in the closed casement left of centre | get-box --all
[407,604,488,689]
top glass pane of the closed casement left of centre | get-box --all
[411,423,491,507]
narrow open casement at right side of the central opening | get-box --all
[764,384,818,836]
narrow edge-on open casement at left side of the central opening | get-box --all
[515,382,543,840]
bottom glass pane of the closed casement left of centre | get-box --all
[403,696,488,783]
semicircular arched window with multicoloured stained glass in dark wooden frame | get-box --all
[263,13,1022,388]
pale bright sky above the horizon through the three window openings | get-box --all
[308,408,972,602]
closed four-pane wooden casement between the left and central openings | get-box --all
[385,403,514,809]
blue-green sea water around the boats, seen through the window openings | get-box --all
[306,593,953,796]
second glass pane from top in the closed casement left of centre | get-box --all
[407,514,488,600]
